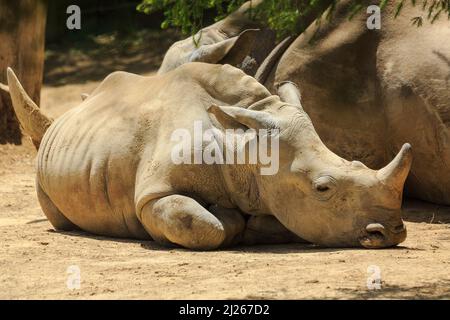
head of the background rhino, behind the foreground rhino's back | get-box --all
[158,0,275,74]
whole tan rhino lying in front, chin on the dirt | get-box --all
[8,63,412,249]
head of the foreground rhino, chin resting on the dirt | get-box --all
[212,96,412,248]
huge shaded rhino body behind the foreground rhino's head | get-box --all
[162,0,450,205]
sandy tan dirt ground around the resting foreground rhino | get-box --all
[0,31,450,299]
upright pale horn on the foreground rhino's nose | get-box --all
[377,143,412,191]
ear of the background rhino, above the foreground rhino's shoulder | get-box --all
[189,29,260,65]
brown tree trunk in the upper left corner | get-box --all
[0,0,47,144]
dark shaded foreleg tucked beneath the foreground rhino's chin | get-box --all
[242,216,307,245]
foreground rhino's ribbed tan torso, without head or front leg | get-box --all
[37,64,270,237]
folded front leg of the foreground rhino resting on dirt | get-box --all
[140,195,245,250]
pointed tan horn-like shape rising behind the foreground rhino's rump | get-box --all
[7,68,52,148]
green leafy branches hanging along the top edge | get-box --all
[137,0,450,37]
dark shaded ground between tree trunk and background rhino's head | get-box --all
[44,29,182,87]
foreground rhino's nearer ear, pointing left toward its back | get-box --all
[208,105,278,130]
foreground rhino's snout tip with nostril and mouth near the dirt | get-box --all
[360,222,406,249]
